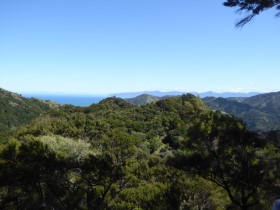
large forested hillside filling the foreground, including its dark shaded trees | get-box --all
[0,94,280,210]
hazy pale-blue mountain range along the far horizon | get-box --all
[110,91,260,99]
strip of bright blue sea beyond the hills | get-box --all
[21,94,106,106]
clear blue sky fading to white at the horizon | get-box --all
[0,0,280,94]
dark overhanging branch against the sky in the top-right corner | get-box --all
[224,0,280,27]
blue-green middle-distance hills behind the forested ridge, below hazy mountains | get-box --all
[125,92,280,131]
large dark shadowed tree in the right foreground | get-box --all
[171,112,270,210]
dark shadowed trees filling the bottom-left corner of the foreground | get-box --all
[0,140,122,209]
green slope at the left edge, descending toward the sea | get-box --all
[0,88,58,133]
